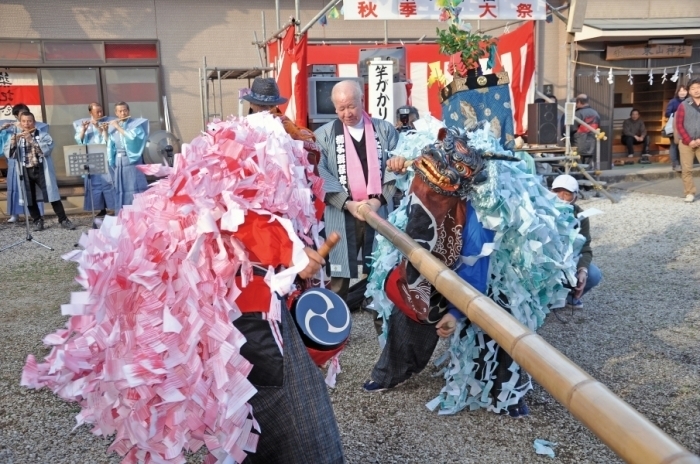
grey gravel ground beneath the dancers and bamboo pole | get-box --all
[0,193,700,464]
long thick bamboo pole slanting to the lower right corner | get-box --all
[358,205,700,464]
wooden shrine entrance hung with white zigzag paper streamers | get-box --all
[574,18,700,169]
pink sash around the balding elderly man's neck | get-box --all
[343,113,382,201]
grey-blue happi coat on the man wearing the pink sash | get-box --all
[315,118,399,278]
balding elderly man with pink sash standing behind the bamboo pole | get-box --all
[315,80,403,299]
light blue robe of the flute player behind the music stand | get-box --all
[73,116,115,211]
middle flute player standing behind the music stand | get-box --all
[73,102,114,217]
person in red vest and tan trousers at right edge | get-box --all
[674,78,700,203]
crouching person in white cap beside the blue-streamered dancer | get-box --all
[552,174,603,309]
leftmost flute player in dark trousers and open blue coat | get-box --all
[5,111,75,231]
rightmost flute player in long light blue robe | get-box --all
[107,102,148,213]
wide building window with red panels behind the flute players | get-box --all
[0,39,162,184]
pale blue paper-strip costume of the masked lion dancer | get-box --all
[367,115,581,414]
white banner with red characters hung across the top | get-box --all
[343,0,547,21]
